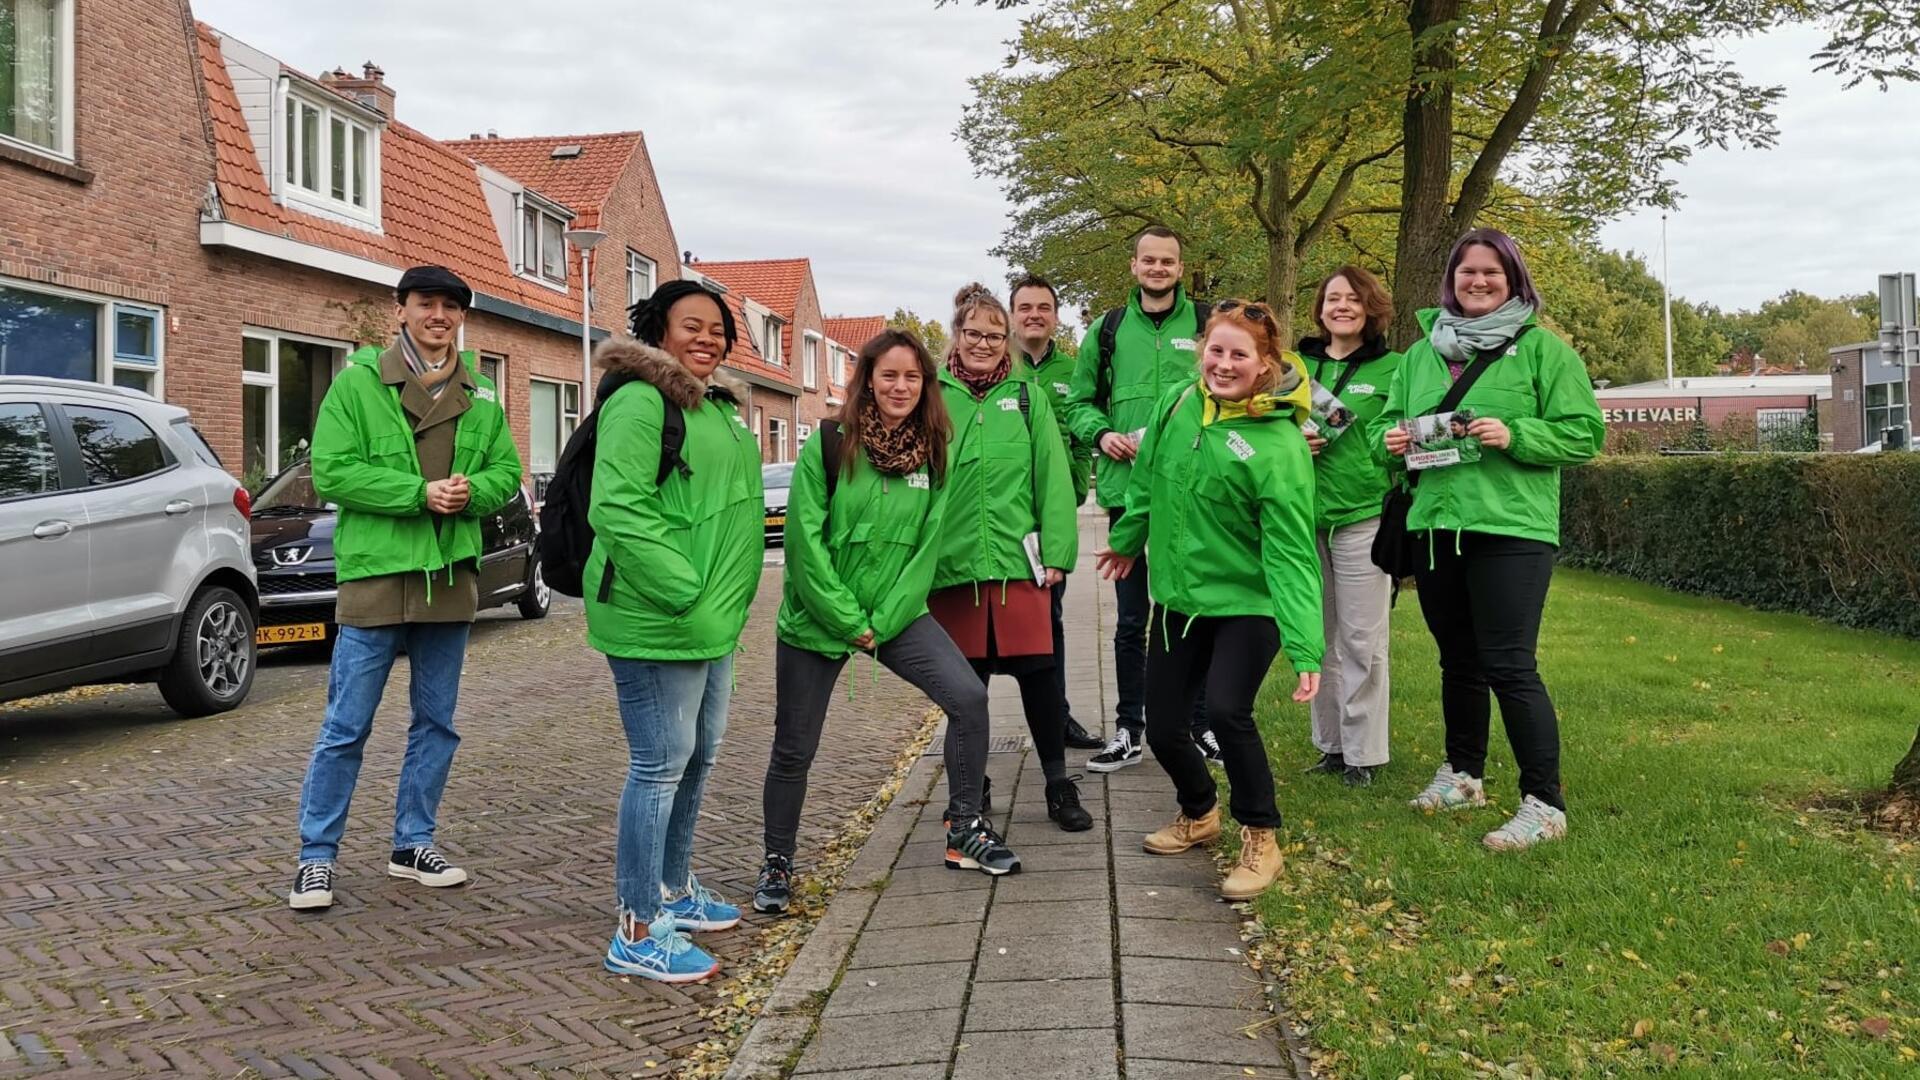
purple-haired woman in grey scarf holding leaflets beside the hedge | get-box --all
[1375,229,1607,851]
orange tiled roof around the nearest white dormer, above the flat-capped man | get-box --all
[198,23,580,319]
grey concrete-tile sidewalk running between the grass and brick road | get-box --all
[728,515,1308,1080]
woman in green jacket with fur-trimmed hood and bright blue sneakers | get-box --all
[584,281,766,982]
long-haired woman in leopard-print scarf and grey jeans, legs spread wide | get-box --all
[753,331,1018,913]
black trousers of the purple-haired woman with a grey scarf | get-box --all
[1413,532,1567,809]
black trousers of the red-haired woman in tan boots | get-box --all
[1135,607,1281,828]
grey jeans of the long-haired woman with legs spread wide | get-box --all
[760,615,987,859]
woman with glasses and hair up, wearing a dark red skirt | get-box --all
[927,284,1092,845]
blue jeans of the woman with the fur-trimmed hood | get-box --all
[607,655,733,920]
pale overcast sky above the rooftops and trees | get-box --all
[194,0,1920,317]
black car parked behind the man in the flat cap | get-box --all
[253,449,553,646]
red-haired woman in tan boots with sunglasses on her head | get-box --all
[1100,300,1323,899]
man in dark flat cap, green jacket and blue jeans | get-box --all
[288,267,520,909]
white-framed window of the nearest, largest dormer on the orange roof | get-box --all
[280,86,380,225]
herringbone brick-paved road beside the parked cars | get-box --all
[0,571,925,1078]
